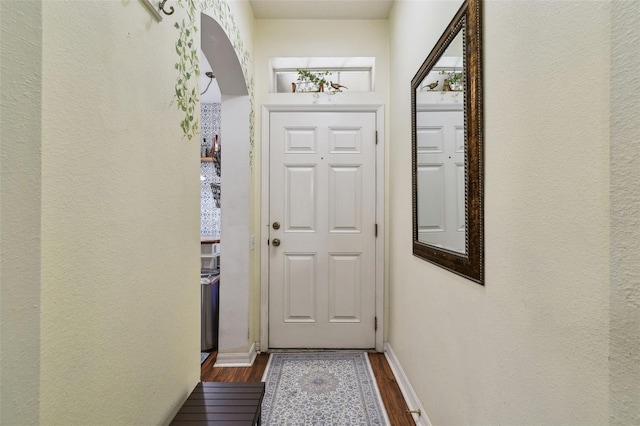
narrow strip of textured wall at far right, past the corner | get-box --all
[610,1,640,425]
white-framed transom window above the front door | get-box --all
[269,57,375,93]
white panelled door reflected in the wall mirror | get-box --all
[416,105,466,253]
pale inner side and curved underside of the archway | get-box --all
[200,13,255,365]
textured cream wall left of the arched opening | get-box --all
[0,1,253,425]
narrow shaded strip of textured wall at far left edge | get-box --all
[0,1,42,424]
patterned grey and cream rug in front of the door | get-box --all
[262,352,389,426]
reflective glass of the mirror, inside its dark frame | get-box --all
[416,31,466,254]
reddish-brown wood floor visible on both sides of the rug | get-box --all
[200,352,415,426]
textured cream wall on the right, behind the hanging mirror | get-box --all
[389,0,610,424]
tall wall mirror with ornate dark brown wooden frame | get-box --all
[411,0,484,285]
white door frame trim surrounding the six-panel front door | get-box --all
[260,104,385,352]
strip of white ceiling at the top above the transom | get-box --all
[250,0,393,19]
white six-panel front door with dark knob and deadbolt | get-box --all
[269,112,376,348]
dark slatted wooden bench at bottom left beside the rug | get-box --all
[171,382,264,426]
